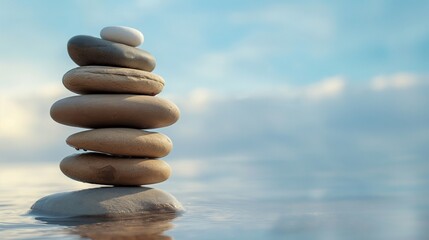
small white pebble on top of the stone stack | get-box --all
[100,26,144,47]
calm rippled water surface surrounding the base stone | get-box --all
[0,159,429,239]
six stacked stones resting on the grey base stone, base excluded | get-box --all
[51,27,179,186]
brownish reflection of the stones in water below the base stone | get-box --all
[36,213,177,240]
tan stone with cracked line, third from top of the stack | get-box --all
[63,66,165,96]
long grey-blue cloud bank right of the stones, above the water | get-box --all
[162,73,429,167]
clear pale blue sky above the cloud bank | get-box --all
[0,0,429,93]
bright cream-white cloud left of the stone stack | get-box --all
[0,84,70,148]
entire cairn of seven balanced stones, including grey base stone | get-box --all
[31,27,184,217]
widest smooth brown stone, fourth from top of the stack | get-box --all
[51,94,180,129]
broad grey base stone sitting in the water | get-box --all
[31,187,184,217]
